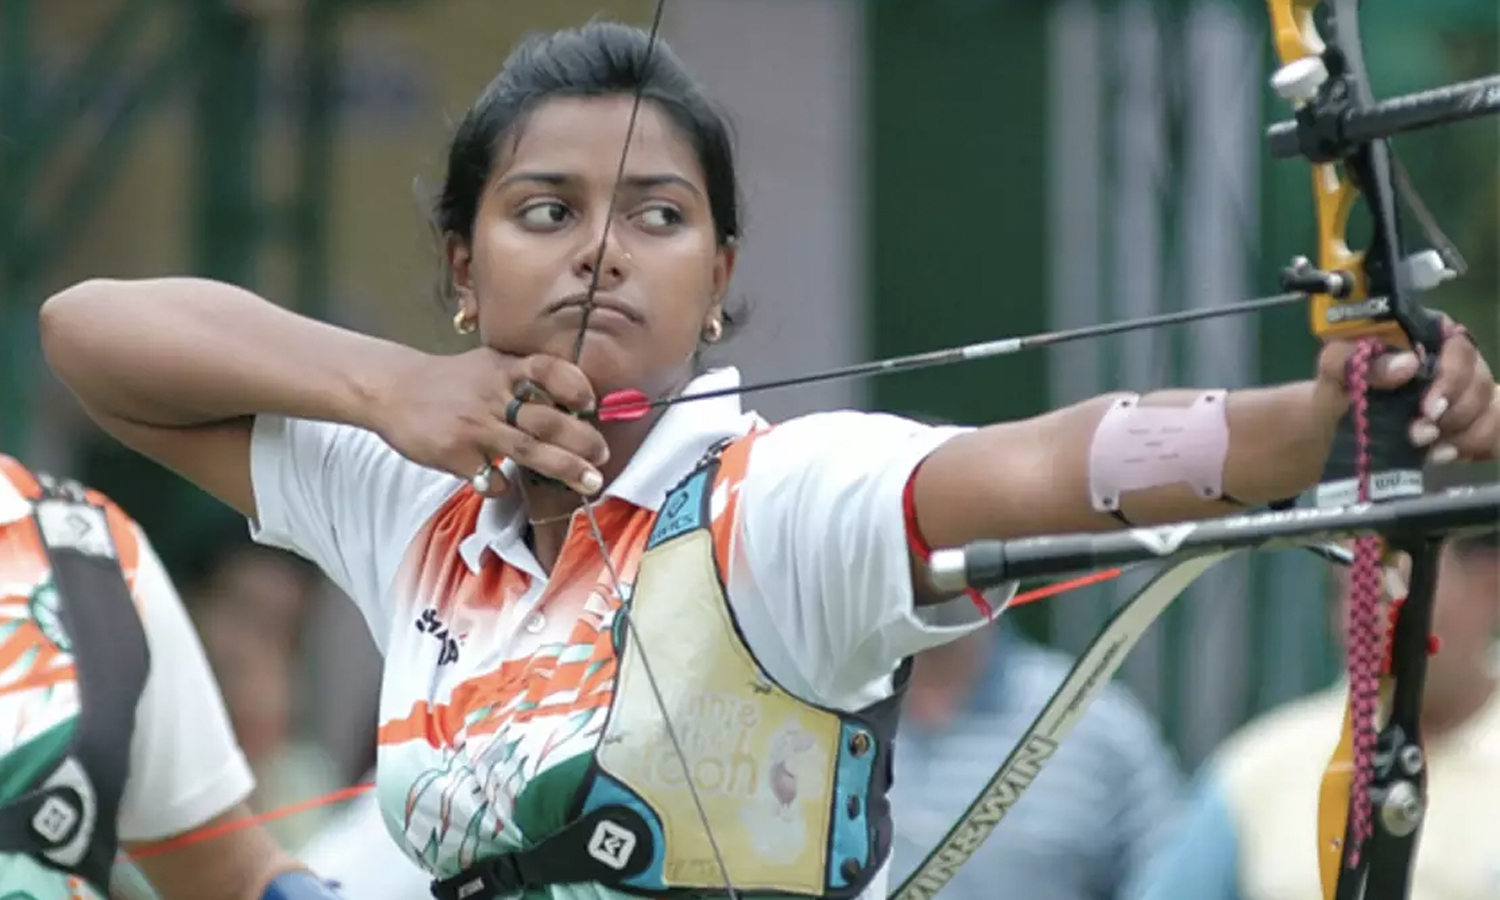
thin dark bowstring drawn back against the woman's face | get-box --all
[573,0,740,900]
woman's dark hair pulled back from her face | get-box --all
[434,21,743,357]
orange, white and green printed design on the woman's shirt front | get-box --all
[380,453,746,876]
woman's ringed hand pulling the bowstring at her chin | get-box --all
[375,347,609,497]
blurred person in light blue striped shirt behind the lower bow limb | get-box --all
[891,621,1182,900]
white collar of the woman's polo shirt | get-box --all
[459,368,765,576]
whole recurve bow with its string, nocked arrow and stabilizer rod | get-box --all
[552,0,1500,900]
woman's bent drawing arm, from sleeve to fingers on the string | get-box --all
[41,278,603,519]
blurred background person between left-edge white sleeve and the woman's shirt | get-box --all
[186,530,345,851]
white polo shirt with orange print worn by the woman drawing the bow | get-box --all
[252,369,1010,899]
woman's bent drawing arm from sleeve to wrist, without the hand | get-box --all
[41,278,423,519]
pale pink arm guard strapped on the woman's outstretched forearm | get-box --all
[1089,390,1229,513]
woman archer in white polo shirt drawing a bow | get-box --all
[42,23,1500,899]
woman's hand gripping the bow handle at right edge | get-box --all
[1317,317,1500,464]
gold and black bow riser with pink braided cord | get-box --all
[1268,0,1448,900]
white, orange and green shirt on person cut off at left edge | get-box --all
[0,462,255,900]
